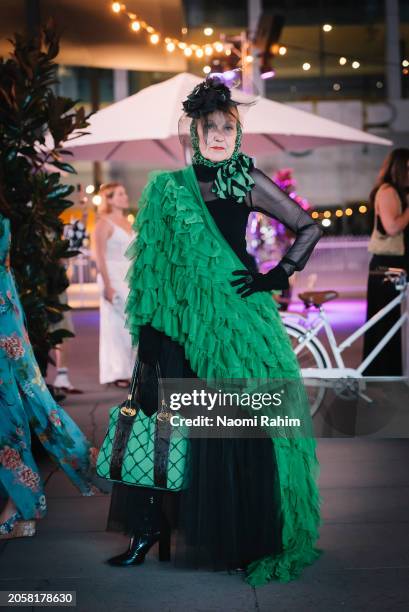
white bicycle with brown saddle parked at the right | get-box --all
[281,268,408,415]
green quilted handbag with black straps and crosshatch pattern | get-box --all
[96,360,188,491]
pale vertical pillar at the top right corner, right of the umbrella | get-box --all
[385,0,402,100]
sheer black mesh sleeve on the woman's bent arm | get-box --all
[247,168,324,276]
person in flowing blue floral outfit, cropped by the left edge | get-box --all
[0,214,94,538]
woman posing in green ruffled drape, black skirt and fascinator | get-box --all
[108,78,322,585]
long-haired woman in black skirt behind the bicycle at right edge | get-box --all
[363,149,409,376]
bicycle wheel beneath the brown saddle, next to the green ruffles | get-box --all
[283,321,327,416]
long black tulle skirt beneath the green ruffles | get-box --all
[107,326,281,570]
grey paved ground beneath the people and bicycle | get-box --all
[0,311,409,612]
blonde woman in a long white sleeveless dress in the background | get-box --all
[94,183,135,388]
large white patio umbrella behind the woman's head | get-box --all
[66,73,392,168]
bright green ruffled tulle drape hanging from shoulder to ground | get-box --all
[126,166,320,586]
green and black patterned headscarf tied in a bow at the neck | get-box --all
[190,119,255,203]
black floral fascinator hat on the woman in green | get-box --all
[183,76,237,119]
